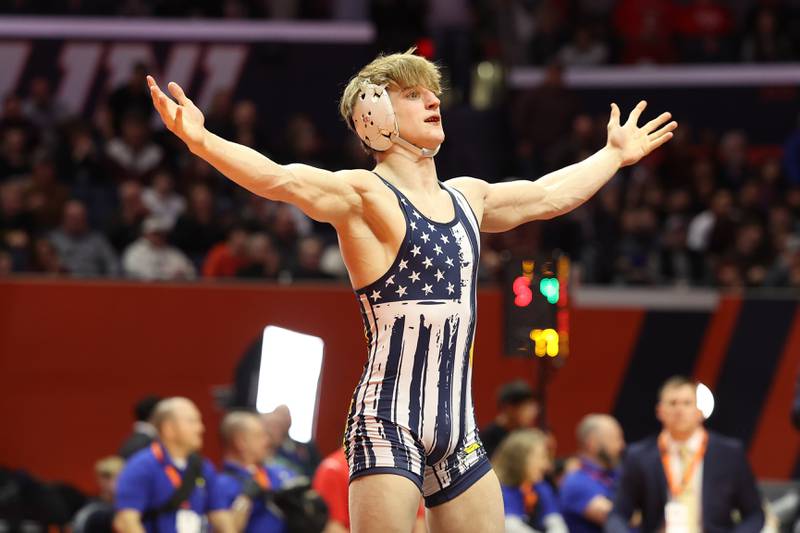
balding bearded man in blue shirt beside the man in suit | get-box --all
[561,414,625,533]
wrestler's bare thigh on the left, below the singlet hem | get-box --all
[350,474,420,533]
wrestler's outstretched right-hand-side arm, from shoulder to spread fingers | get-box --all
[465,101,678,232]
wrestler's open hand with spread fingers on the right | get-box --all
[606,100,678,166]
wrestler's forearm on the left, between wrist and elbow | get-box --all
[189,130,292,201]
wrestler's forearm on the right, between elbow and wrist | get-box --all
[530,147,622,220]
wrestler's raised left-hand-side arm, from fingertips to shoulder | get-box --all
[147,76,361,225]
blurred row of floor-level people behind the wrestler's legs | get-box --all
[0,376,800,533]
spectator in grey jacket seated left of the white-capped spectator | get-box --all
[50,200,119,277]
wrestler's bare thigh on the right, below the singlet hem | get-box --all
[426,470,505,533]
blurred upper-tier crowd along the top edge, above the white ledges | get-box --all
[0,0,800,67]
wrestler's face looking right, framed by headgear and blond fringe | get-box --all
[389,85,444,150]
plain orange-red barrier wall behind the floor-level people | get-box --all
[0,280,796,490]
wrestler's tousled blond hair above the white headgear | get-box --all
[339,47,442,131]
